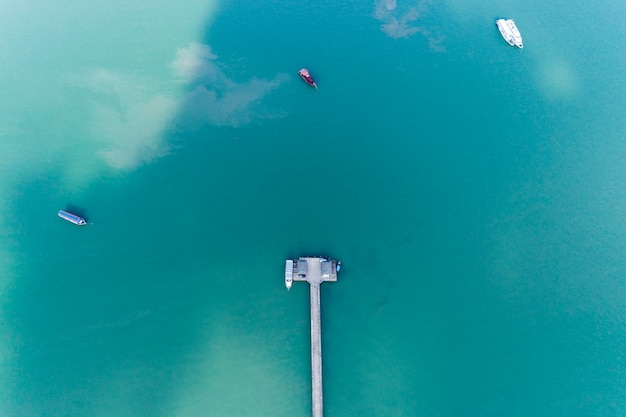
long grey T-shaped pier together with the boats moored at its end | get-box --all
[285,257,341,417]
